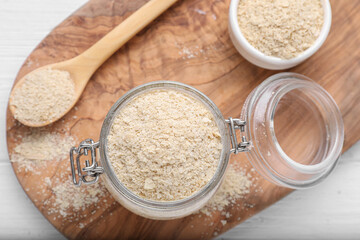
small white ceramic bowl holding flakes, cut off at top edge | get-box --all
[229,0,331,70]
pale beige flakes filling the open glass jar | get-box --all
[108,89,222,201]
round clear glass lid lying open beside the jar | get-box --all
[241,73,344,189]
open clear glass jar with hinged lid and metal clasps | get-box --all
[70,73,344,219]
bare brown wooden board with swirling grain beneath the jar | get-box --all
[7,1,360,239]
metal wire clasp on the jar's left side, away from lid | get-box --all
[70,139,104,186]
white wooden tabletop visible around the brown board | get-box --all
[0,0,360,239]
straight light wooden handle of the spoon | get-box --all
[76,0,177,75]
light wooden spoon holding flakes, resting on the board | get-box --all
[9,0,177,127]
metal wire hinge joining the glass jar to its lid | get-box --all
[225,117,250,154]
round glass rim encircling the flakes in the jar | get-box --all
[99,81,230,217]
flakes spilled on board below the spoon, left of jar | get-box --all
[10,128,115,228]
